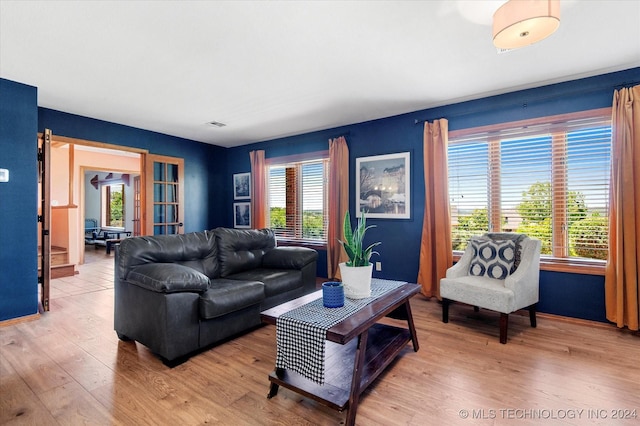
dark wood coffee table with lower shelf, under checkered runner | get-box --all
[261,284,420,425]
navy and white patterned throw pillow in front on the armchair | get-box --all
[469,237,516,280]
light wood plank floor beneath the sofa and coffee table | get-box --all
[0,248,640,425]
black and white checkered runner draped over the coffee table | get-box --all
[276,278,406,385]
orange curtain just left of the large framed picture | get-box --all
[327,136,349,278]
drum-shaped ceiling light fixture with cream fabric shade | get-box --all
[493,0,560,49]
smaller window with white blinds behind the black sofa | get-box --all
[269,158,329,243]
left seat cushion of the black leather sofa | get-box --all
[198,278,264,319]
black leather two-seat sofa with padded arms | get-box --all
[114,228,318,365]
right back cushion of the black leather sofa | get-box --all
[214,228,276,277]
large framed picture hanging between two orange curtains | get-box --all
[356,152,411,219]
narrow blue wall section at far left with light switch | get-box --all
[0,79,38,321]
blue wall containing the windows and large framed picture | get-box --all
[227,68,640,321]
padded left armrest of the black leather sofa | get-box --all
[126,263,209,293]
